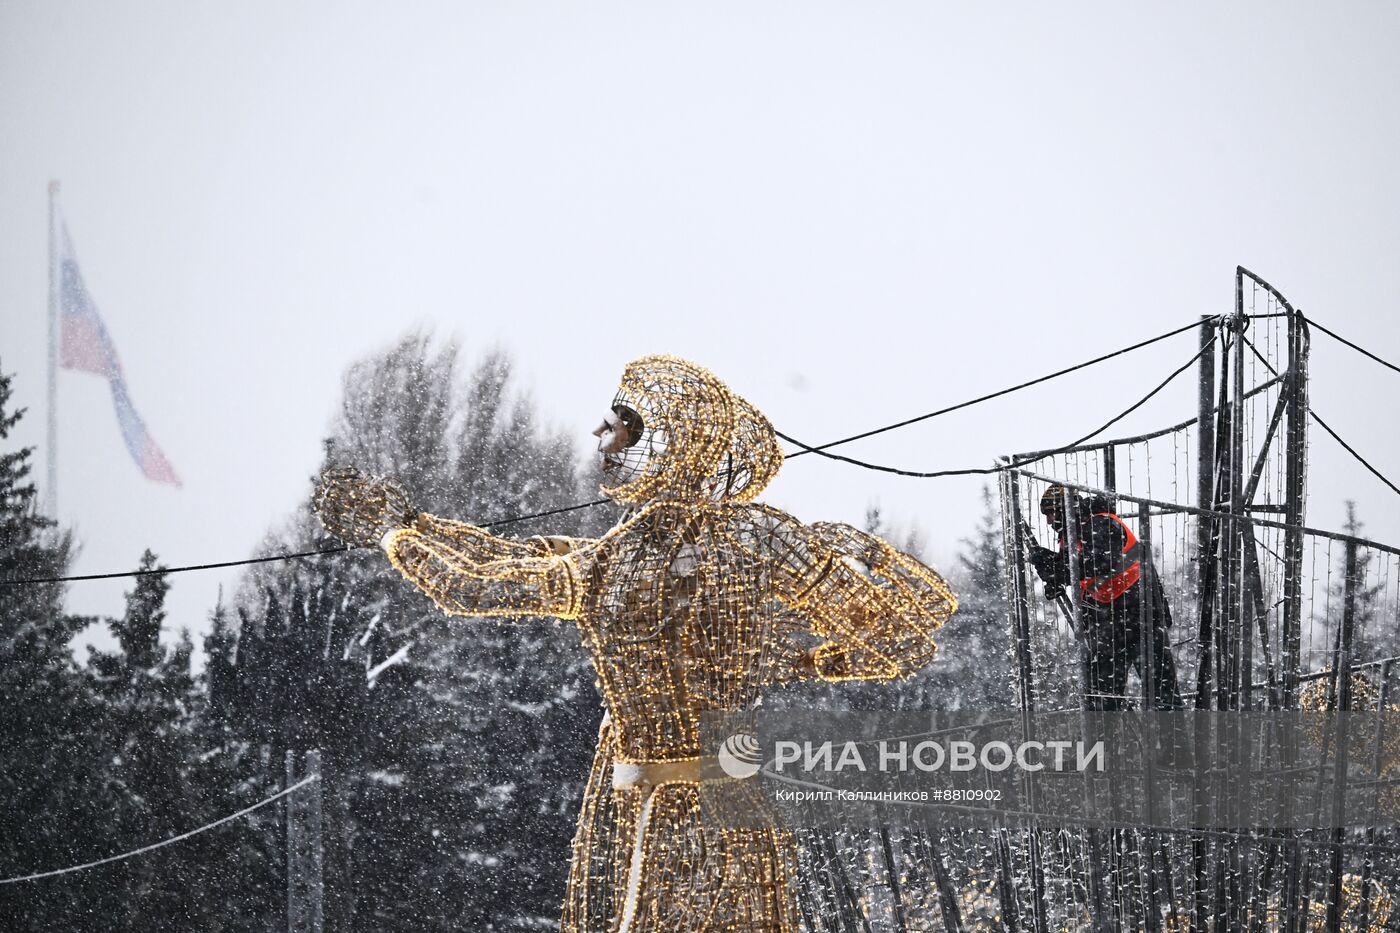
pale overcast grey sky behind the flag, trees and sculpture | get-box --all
[0,0,1400,652]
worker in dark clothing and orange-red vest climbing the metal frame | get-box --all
[1030,485,1183,710]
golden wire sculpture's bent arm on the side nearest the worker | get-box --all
[753,506,958,681]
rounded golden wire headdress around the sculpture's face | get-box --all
[602,356,783,503]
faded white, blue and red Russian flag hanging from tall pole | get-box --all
[57,224,181,486]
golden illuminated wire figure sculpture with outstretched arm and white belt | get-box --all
[315,356,956,933]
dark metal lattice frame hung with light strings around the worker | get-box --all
[1001,269,1400,933]
